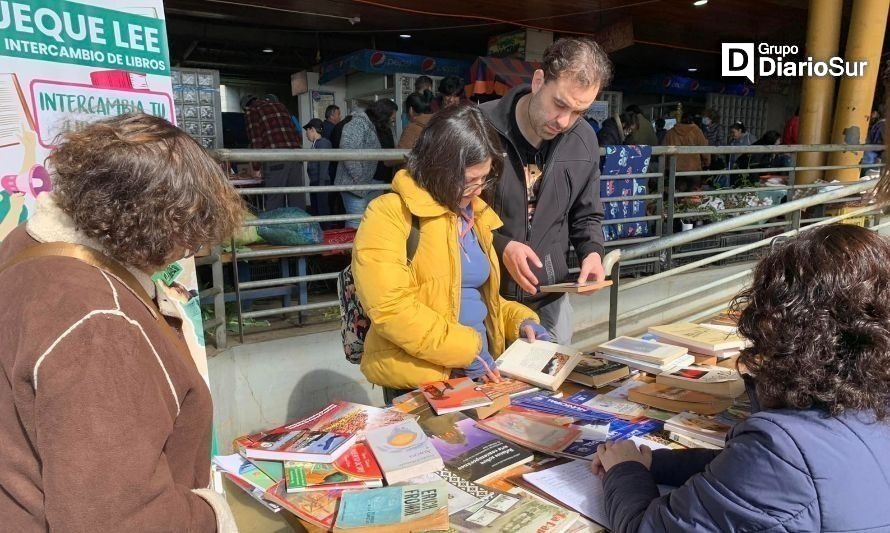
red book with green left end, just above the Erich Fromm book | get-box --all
[284,442,383,492]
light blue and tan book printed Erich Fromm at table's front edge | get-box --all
[334,481,448,533]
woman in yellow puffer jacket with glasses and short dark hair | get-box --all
[352,106,549,401]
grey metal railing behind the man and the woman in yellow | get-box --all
[202,145,883,346]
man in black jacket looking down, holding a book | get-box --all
[480,38,612,344]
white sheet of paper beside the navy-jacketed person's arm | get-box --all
[522,461,609,528]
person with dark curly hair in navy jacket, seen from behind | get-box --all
[592,224,890,532]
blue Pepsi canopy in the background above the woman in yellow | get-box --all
[318,48,469,85]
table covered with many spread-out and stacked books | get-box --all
[214,314,749,533]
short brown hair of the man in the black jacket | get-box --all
[541,37,612,88]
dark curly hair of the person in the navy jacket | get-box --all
[732,224,890,420]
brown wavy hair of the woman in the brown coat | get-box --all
[49,113,242,269]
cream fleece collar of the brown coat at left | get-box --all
[25,193,156,299]
